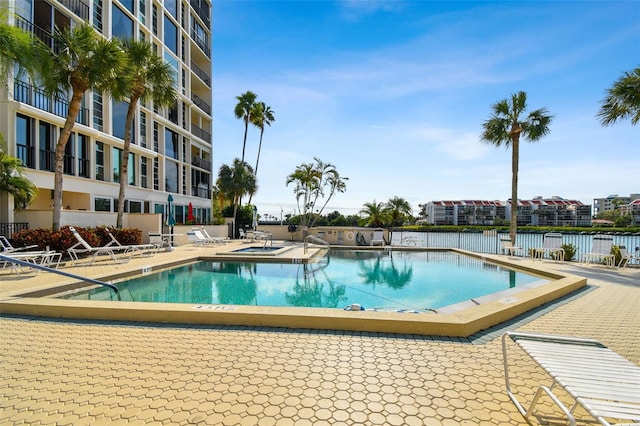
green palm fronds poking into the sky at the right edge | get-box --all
[596,67,640,126]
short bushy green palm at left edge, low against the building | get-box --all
[0,135,38,208]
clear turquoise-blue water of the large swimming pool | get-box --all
[63,250,544,311]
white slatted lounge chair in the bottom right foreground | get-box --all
[502,332,640,426]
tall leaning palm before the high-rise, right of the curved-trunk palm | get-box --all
[112,40,177,228]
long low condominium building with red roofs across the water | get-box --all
[426,197,591,226]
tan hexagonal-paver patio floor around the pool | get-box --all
[0,248,640,425]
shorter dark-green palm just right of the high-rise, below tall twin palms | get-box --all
[216,158,258,235]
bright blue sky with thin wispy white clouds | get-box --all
[213,0,640,217]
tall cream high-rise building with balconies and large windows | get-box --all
[0,0,213,225]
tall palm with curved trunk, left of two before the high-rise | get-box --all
[42,23,127,232]
